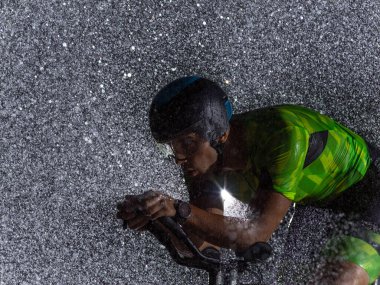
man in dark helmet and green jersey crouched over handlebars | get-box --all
[118,76,380,284]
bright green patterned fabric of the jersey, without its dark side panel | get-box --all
[216,105,370,203]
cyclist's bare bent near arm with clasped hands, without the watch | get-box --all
[119,191,291,251]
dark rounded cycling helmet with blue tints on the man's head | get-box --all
[149,76,232,147]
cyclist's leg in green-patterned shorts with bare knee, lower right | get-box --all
[322,145,380,284]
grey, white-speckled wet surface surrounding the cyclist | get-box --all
[0,0,380,285]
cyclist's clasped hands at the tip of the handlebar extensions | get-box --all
[117,191,176,230]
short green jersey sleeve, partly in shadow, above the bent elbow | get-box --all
[255,126,309,201]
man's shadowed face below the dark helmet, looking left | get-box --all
[169,133,218,176]
